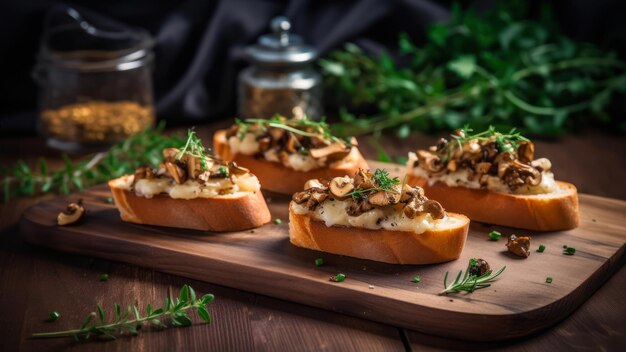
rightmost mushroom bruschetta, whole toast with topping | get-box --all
[407,127,579,231]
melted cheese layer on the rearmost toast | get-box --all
[228,133,358,172]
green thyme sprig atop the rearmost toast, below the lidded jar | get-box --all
[235,114,345,142]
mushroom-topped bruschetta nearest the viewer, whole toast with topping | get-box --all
[289,169,469,264]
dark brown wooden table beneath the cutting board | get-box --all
[0,124,626,351]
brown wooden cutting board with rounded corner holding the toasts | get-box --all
[21,162,626,341]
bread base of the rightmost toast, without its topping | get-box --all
[407,174,579,231]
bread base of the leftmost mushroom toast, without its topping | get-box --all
[109,176,271,231]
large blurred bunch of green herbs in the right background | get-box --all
[321,1,626,137]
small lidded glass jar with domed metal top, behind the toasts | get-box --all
[238,17,322,118]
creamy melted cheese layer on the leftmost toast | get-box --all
[108,174,261,199]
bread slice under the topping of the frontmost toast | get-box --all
[289,202,470,264]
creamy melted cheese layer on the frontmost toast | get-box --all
[291,199,459,234]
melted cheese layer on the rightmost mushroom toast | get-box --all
[407,153,558,195]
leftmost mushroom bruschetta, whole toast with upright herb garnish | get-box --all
[109,130,271,231]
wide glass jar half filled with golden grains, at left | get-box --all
[34,7,155,151]
